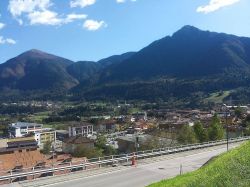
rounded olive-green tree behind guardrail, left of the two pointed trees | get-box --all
[177,125,197,144]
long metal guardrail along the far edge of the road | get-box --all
[0,136,250,182]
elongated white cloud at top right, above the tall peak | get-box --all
[196,0,240,14]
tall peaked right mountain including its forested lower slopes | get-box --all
[81,26,250,103]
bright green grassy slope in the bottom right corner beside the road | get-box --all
[149,142,250,187]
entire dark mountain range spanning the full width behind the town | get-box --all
[0,26,250,105]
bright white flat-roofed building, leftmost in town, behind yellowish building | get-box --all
[9,122,43,138]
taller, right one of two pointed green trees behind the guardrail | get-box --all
[208,115,224,141]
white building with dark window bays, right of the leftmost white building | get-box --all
[69,123,93,137]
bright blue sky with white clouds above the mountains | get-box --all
[0,0,250,63]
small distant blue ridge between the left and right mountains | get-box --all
[98,52,136,67]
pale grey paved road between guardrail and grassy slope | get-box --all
[10,143,241,187]
